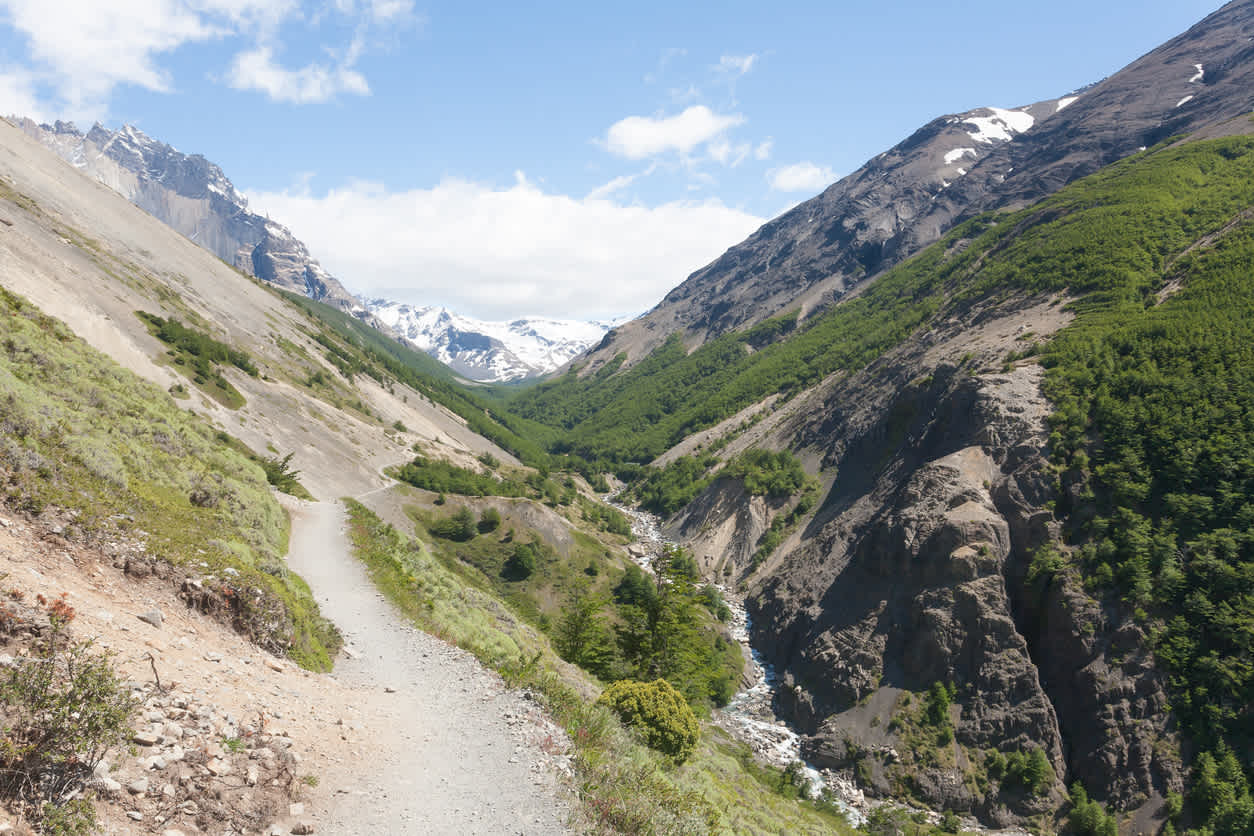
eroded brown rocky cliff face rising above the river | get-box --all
[670,297,1183,825]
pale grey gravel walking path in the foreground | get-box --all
[288,503,569,835]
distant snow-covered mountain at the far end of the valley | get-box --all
[366,298,612,382]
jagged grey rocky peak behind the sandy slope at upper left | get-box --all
[13,118,365,313]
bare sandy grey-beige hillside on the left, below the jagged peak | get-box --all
[0,120,513,499]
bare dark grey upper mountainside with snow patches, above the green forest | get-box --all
[586,3,1254,371]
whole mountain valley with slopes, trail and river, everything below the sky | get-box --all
[0,0,1254,836]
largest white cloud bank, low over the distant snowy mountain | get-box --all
[248,177,764,318]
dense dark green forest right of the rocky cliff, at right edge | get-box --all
[1043,213,1254,833]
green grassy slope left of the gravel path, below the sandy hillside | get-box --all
[0,288,339,669]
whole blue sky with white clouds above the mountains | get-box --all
[0,0,1219,318]
